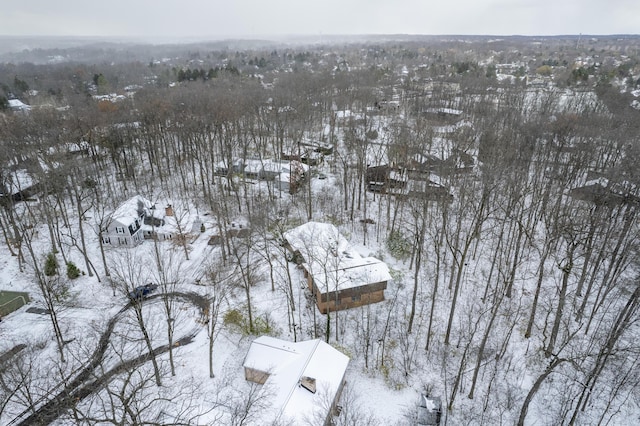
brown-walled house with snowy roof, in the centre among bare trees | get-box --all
[283,222,391,314]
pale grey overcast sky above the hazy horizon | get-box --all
[0,0,640,39]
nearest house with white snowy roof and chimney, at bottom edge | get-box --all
[243,336,349,425]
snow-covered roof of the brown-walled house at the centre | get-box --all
[283,222,391,291]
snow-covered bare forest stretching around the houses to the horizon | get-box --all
[0,37,640,425]
